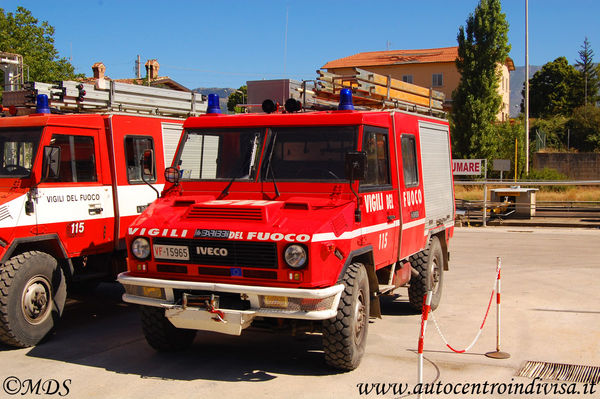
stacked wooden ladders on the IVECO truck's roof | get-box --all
[315,68,445,113]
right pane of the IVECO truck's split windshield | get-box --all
[262,126,358,181]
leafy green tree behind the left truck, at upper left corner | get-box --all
[0,7,83,92]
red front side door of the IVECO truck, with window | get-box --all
[360,126,399,268]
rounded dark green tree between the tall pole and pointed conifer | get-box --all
[521,57,580,118]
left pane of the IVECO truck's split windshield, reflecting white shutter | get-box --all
[178,129,265,180]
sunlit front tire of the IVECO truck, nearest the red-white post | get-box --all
[323,263,370,370]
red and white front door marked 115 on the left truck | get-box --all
[33,127,114,256]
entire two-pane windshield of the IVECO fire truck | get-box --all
[177,126,358,181]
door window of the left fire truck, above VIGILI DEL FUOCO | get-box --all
[50,134,98,183]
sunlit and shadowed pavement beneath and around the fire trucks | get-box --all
[0,227,600,398]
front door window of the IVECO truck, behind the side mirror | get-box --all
[361,126,390,186]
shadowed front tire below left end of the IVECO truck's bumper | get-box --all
[140,306,196,352]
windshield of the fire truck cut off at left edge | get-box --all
[0,128,42,177]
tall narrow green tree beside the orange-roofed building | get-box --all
[450,0,510,159]
